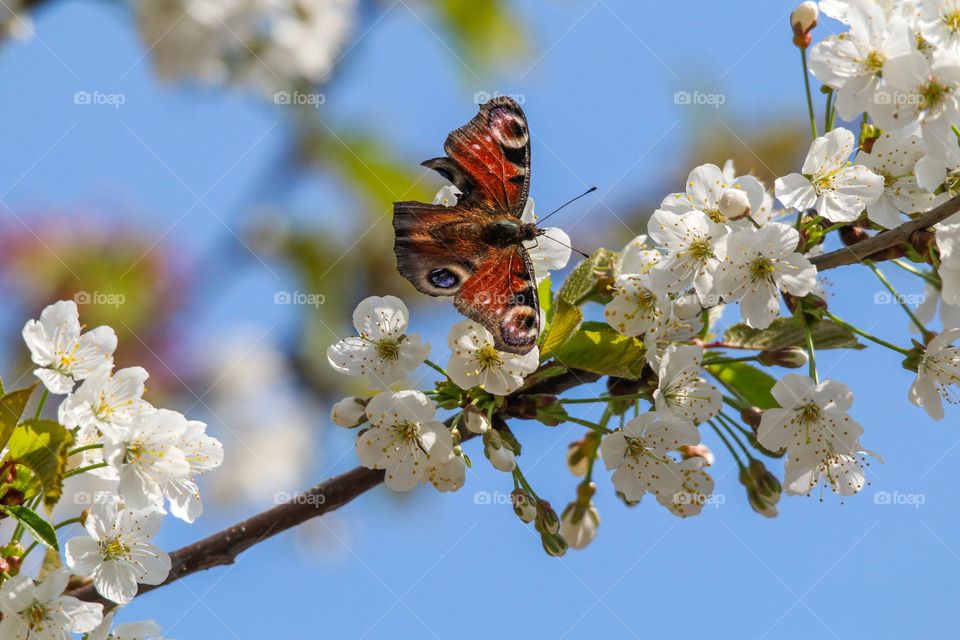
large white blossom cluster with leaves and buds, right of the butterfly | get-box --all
[327,0,960,555]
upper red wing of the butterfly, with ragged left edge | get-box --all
[423,96,530,218]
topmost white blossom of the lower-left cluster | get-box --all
[23,300,117,394]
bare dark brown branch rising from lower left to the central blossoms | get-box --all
[67,370,600,608]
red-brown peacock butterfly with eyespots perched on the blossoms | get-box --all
[393,96,543,354]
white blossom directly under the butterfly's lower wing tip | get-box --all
[447,320,540,396]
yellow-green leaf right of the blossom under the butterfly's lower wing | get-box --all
[554,322,647,378]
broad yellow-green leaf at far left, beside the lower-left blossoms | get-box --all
[7,419,73,507]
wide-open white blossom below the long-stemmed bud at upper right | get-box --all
[775,129,883,222]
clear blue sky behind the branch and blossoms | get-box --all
[0,0,960,640]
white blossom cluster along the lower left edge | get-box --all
[0,301,223,640]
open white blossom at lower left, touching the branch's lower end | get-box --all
[66,497,170,605]
